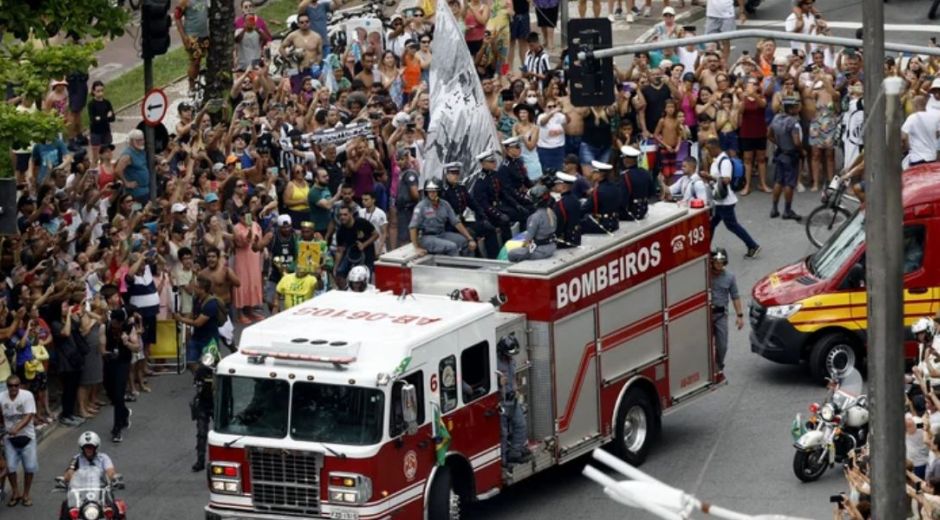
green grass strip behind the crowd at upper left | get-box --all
[97,0,298,119]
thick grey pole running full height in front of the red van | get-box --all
[862,0,908,518]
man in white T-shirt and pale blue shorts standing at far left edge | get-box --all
[0,375,39,506]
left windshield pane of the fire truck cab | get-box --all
[215,376,290,439]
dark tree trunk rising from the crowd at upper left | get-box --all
[205,0,235,106]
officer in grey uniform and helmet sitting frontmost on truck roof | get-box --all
[408,179,477,256]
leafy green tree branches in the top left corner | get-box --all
[0,0,128,178]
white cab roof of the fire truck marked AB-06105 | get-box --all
[239,291,496,373]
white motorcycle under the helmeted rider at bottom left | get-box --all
[56,466,127,520]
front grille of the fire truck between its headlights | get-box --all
[248,448,322,514]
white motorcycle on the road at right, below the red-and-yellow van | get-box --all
[792,365,869,482]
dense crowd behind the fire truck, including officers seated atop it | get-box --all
[0,0,940,510]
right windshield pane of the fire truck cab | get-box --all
[290,382,385,446]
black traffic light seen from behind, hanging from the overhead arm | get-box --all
[568,18,615,107]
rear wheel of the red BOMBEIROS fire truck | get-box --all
[614,388,659,466]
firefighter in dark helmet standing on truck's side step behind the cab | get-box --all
[496,334,532,465]
